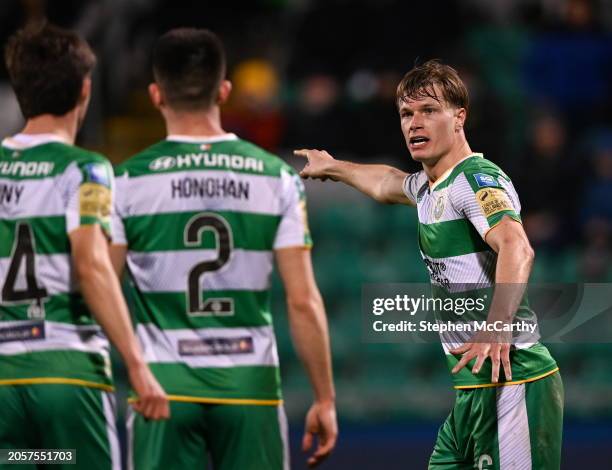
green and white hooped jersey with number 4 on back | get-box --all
[0,134,113,390]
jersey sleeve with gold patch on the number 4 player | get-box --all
[66,157,114,239]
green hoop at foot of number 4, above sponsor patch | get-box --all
[0,293,95,325]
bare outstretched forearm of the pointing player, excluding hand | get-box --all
[327,160,407,204]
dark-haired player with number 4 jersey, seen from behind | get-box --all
[0,21,168,470]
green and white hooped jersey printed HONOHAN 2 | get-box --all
[113,134,311,405]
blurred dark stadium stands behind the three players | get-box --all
[0,0,612,469]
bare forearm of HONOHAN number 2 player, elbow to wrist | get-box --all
[287,294,336,402]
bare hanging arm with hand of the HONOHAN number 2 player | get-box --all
[276,247,338,467]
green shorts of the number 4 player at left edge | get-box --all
[0,384,121,470]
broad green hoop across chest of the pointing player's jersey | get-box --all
[419,219,491,258]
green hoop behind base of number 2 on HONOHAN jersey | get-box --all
[126,287,272,330]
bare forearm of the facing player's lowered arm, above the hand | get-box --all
[489,242,534,322]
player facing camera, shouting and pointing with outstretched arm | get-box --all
[295,61,563,470]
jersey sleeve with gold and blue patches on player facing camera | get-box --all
[450,166,521,239]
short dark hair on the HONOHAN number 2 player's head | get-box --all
[153,28,225,110]
